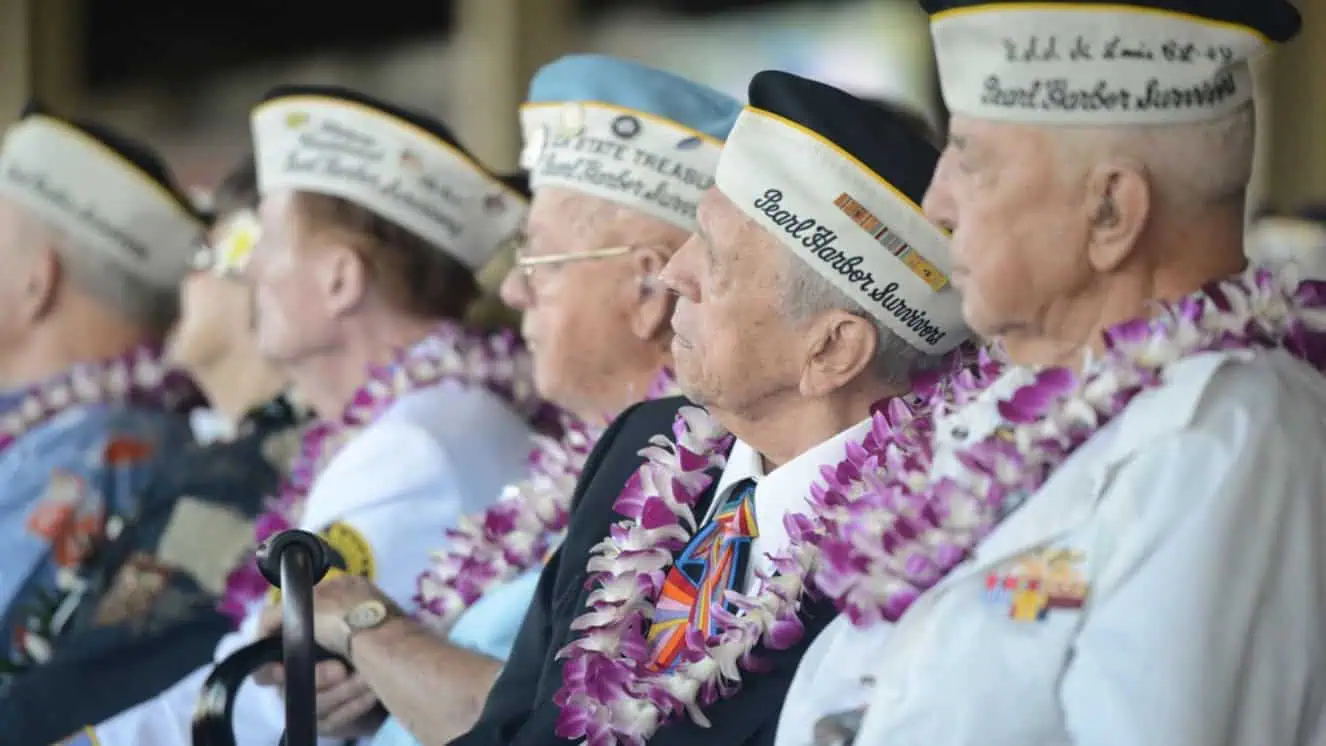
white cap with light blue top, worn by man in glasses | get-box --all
[520,54,743,231]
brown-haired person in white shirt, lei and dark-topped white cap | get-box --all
[64,86,542,746]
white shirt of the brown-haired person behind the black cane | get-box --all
[88,382,530,746]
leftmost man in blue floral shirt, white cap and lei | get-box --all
[0,106,204,683]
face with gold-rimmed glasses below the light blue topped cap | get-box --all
[501,187,657,417]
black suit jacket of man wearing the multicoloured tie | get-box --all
[452,398,833,746]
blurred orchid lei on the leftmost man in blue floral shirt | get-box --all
[0,345,202,452]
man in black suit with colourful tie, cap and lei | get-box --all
[453,72,965,746]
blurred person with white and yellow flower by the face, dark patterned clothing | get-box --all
[0,158,301,743]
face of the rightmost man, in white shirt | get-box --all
[924,115,1090,342]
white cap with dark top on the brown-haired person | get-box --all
[251,85,529,269]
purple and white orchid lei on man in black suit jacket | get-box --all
[556,348,971,746]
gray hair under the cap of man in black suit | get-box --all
[782,257,944,386]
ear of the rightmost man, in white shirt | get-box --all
[1086,160,1151,273]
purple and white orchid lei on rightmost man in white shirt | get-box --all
[788,265,1326,627]
